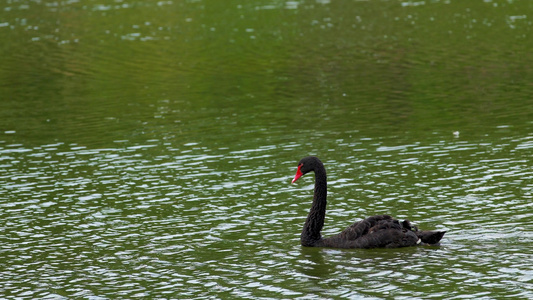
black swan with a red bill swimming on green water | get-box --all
[292,156,446,248]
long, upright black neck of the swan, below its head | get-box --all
[301,164,328,246]
